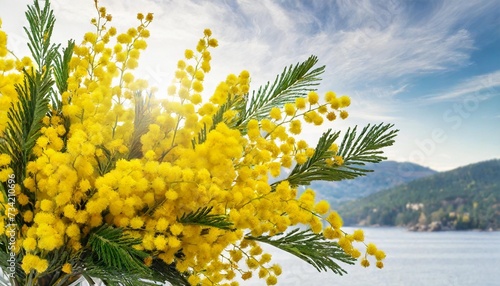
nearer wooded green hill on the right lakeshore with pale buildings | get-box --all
[339,160,500,230]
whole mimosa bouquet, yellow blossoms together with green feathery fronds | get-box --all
[0,0,397,286]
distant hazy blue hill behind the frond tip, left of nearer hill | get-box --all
[311,161,437,206]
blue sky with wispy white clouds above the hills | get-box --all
[0,0,500,171]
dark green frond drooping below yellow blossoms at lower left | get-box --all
[87,224,149,273]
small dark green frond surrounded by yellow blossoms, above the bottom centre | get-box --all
[177,207,233,229]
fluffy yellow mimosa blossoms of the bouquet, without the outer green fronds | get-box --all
[0,2,394,285]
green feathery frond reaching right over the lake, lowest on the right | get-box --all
[246,228,356,275]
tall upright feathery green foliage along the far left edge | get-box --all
[0,0,58,178]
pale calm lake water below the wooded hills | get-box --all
[254,228,500,286]
